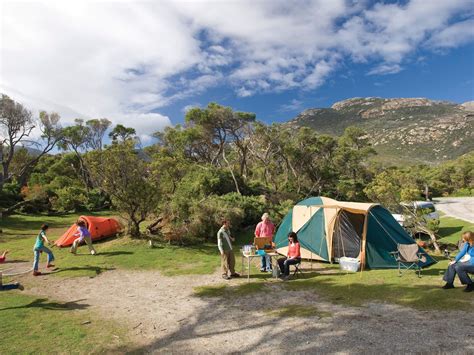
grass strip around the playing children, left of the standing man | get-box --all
[0,212,220,277]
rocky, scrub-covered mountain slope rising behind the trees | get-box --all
[288,97,474,164]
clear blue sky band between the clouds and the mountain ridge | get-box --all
[161,43,474,123]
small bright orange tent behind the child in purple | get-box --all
[54,216,122,247]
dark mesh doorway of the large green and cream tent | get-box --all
[332,210,365,261]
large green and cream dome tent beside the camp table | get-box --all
[275,197,436,269]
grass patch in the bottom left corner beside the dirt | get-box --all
[0,291,128,354]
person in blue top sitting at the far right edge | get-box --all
[443,231,474,292]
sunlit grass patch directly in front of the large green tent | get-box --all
[284,260,473,310]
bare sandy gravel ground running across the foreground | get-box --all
[21,270,474,353]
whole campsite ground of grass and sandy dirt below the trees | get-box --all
[0,216,474,353]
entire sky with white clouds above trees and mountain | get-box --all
[0,0,474,144]
